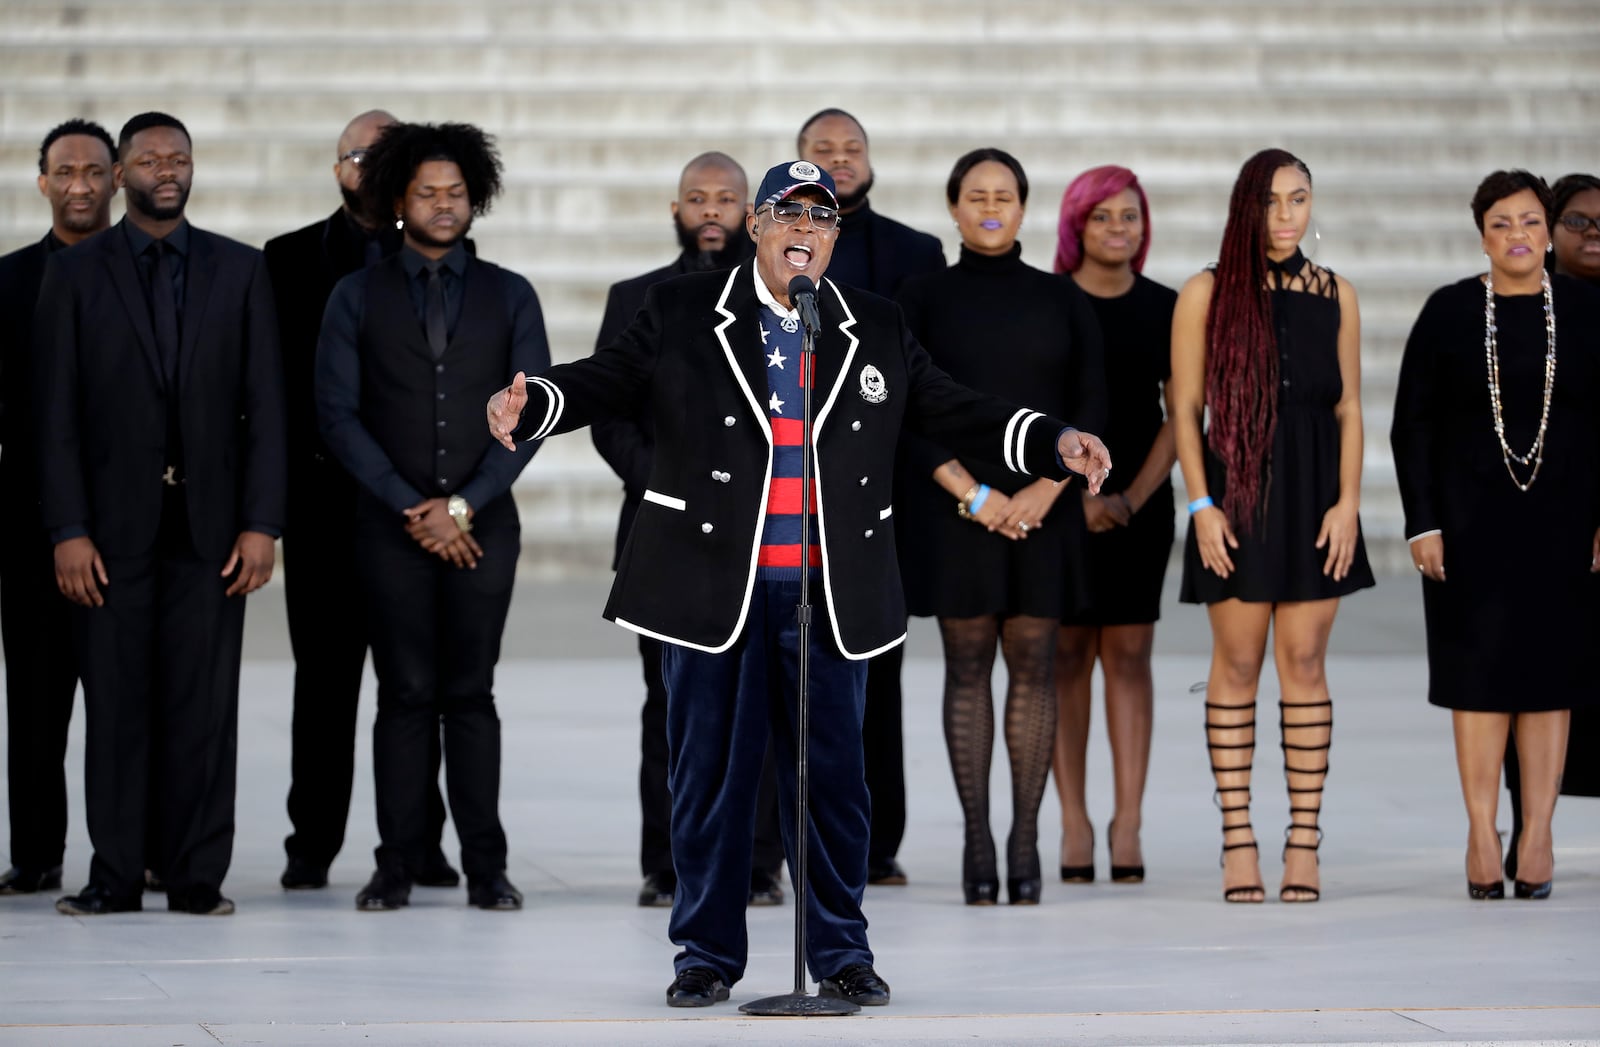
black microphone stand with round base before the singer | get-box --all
[739,277,861,1018]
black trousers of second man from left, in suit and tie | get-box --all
[72,499,245,900]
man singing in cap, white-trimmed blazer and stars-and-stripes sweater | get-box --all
[488,160,1110,1007]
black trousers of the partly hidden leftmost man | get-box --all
[0,515,78,869]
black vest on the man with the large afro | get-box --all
[360,255,512,499]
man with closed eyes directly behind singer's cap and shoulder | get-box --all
[798,109,944,887]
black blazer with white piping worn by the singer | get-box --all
[517,264,1066,658]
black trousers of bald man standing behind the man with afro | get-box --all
[283,458,445,866]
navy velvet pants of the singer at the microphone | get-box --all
[662,580,872,985]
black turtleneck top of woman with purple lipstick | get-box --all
[898,245,1115,491]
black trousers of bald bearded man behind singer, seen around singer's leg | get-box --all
[638,636,784,877]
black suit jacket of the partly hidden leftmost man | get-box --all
[0,234,51,518]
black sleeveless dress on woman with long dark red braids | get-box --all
[1179,251,1373,604]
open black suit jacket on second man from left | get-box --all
[34,226,285,560]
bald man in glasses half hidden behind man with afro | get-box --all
[264,109,461,890]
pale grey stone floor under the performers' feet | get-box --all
[0,580,1600,1047]
